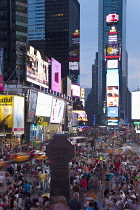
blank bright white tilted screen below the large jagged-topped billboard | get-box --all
[35,92,53,117]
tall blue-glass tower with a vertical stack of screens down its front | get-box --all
[98,0,128,125]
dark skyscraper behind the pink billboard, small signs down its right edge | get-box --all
[46,0,80,89]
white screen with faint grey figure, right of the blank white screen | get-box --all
[50,98,64,123]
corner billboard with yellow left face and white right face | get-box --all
[0,95,25,134]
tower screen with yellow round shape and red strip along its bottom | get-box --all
[106,44,120,58]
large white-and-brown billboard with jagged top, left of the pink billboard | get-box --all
[26,46,49,88]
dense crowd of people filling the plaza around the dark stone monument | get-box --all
[0,142,140,210]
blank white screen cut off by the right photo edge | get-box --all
[131,91,140,120]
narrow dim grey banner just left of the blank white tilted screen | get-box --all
[27,90,38,122]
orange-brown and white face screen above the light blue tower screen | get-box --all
[107,86,119,107]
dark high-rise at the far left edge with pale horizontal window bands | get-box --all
[0,0,28,81]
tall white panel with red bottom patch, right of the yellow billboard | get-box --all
[13,96,25,134]
